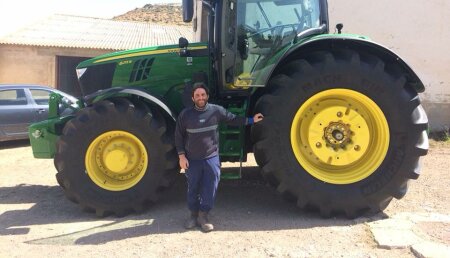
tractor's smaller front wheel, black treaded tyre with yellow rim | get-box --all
[55,98,178,216]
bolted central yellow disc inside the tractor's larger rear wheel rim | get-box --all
[304,104,370,166]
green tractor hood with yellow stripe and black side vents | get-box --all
[77,43,207,96]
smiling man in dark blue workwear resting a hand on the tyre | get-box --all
[175,84,263,232]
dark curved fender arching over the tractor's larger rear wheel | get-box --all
[269,34,425,93]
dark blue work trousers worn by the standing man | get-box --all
[186,156,220,212]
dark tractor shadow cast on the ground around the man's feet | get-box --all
[0,167,386,245]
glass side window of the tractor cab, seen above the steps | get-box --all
[234,0,320,87]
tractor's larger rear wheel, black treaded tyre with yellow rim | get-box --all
[252,50,428,218]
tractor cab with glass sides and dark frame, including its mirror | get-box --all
[183,0,328,96]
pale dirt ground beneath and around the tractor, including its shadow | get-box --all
[0,141,450,258]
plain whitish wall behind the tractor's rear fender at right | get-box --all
[328,0,450,130]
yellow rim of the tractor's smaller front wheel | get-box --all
[85,131,148,191]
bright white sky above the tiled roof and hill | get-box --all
[0,0,181,36]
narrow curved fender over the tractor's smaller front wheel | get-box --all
[84,87,176,122]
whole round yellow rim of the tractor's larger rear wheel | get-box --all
[291,89,389,184]
